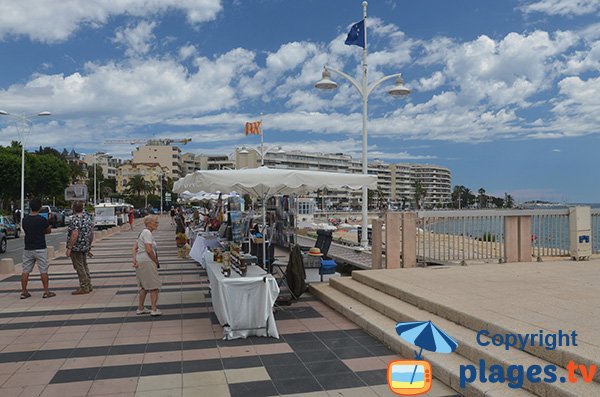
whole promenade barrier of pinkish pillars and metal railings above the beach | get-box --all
[372,207,600,268]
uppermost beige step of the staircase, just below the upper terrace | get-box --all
[352,269,600,382]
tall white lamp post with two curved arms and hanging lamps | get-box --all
[315,1,410,248]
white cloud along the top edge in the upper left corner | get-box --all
[0,0,223,43]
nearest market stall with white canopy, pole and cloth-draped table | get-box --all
[173,167,377,339]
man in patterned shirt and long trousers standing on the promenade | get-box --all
[67,201,94,295]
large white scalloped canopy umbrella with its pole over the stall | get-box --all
[173,167,377,266]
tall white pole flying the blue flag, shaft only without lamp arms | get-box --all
[360,1,369,248]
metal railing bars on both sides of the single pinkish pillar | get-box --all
[417,208,568,263]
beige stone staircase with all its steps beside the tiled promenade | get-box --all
[311,269,600,397]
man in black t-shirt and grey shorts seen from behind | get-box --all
[21,198,56,299]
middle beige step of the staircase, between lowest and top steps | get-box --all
[330,277,600,396]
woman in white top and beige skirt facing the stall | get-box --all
[133,215,162,316]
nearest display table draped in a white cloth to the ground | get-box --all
[200,251,279,339]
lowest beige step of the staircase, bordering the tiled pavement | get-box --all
[311,284,536,397]
